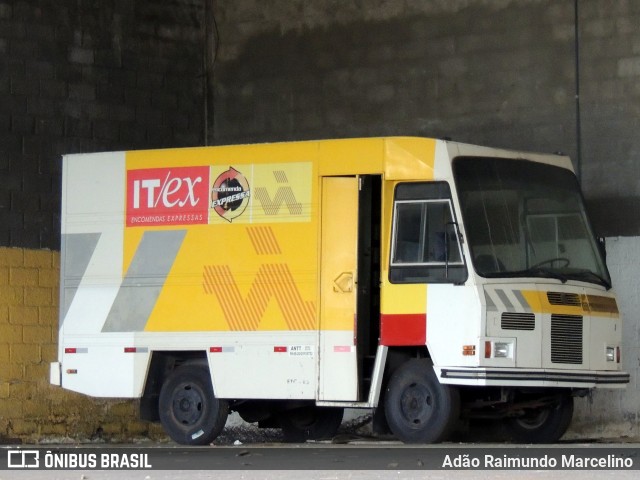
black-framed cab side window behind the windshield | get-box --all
[389,182,467,283]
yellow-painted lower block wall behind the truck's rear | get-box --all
[0,247,164,443]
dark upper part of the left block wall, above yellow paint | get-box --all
[0,0,204,250]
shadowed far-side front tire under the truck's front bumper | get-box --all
[505,395,573,443]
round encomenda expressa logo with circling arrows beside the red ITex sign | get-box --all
[211,167,251,222]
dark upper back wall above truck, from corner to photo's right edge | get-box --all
[211,0,640,237]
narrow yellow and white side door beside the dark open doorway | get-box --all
[318,177,358,401]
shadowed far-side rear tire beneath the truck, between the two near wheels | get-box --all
[280,406,344,443]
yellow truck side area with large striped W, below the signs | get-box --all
[147,223,317,331]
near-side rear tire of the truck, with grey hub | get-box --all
[159,365,229,445]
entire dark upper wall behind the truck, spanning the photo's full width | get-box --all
[0,0,640,250]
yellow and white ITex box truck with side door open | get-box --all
[51,137,629,445]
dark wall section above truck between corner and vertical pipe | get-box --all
[215,0,576,154]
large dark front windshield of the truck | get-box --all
[453,157,611,288]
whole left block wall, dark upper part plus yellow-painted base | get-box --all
[0,0,205,441]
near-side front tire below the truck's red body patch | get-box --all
[384,359,460,443]
